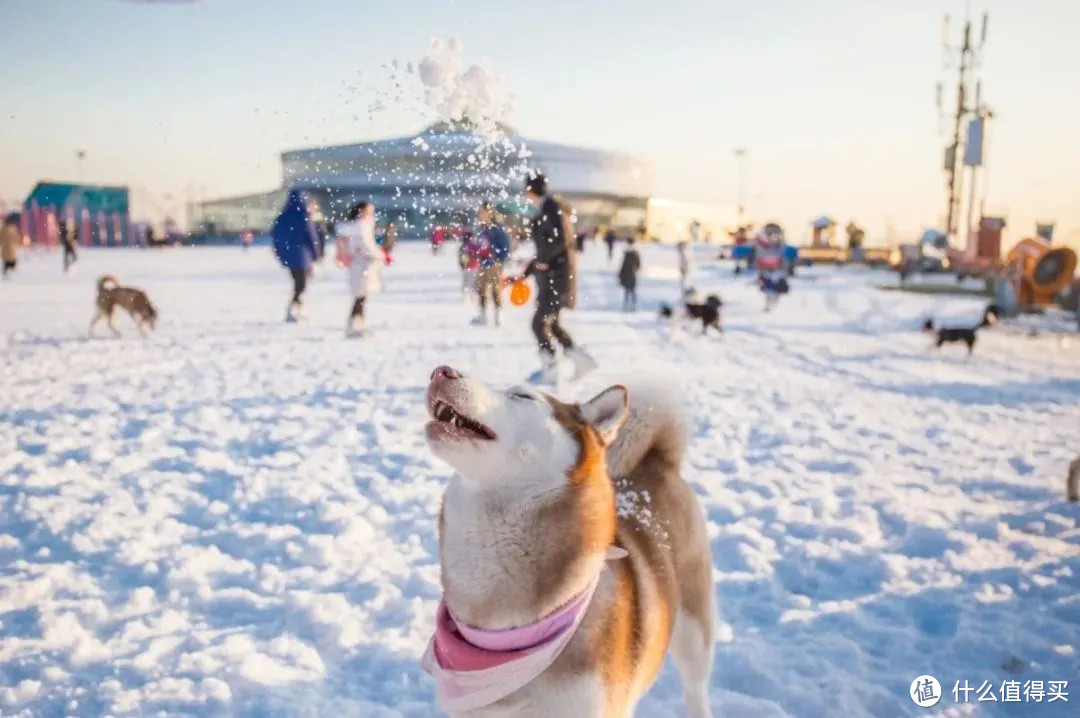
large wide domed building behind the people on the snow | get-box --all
[193,122,652,236]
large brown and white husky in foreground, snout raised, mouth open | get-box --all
[426,366,716,718]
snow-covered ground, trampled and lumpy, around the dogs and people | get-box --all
[0,245,1080,718]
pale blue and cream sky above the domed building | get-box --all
[0,0,1080,244]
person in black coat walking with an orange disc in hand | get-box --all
[516,172,596,383]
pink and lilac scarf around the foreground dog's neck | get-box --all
[421,547,625,713]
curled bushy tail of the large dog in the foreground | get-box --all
[607,384,687,478]
